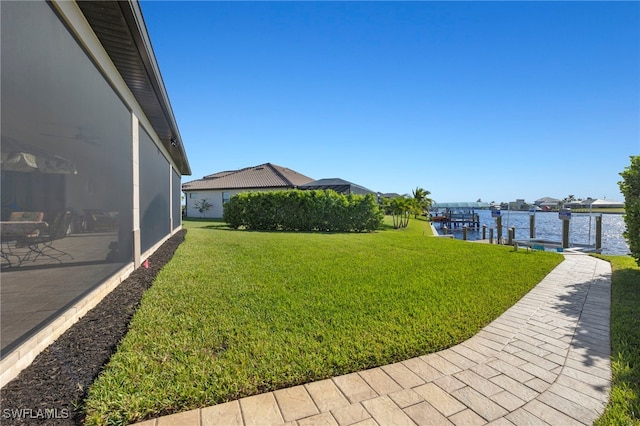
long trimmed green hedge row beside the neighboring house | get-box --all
[223,189,383,232]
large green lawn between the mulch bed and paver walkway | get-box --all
[86,219,562,424]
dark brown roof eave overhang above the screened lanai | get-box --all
[77,0,191,175]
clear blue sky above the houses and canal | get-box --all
[141,1,640,202]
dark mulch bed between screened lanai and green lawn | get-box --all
[0,230,186,425]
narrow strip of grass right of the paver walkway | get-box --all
[595,256,640,426]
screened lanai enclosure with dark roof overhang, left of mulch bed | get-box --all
[0,1,190,384]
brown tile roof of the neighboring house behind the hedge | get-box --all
[182,163,313,191]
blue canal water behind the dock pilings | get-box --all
[435,210,629,255]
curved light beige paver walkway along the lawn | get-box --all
[134,253,611,426]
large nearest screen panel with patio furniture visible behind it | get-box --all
[0,2,133,356]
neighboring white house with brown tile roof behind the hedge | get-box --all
[182,163,313,218]
